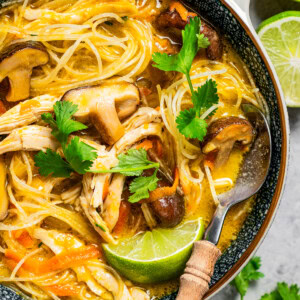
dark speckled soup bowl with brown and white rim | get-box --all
[0,0,289,300]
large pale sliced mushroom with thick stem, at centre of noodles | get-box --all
[62,80,140,145]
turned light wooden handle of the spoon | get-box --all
[176,241,221,300]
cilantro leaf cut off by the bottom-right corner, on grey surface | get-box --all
[261,282,300,300]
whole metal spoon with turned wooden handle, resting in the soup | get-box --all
[176,104,272,300]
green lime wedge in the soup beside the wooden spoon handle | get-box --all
[103,219,204,283]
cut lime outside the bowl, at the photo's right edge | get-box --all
[257,11,300,107]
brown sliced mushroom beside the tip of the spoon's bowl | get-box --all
[202,117,254,168]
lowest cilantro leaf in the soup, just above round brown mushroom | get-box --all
[128,169,159,203]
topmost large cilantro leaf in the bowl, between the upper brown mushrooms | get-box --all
[152,17,203,76]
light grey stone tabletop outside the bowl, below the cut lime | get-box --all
[212,0,300,300]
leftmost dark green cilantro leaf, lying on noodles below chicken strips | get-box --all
[34,148,73,177]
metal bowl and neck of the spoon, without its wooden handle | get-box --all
[204,104,272,245]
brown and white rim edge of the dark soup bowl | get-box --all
[203,0,290,299]
